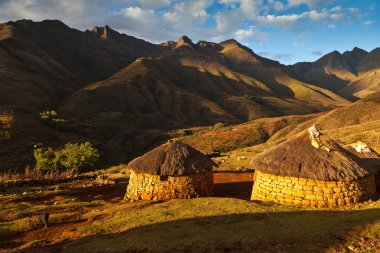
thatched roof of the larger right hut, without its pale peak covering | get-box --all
[251,131,371,181]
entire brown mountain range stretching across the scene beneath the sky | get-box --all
[0,20,380,168]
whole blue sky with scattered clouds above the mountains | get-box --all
[0,0,380,64]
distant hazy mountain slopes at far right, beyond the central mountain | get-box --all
[285,47,380,100]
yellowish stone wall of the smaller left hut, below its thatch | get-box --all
[125,171,214,201]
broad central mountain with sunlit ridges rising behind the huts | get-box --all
[60,37,347,131]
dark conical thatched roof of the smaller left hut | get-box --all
[128,141,218,176]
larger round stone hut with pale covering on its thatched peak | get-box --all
[251,127,376,207]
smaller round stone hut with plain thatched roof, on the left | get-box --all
[125,141,217,201]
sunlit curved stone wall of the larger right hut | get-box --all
[251,171,376,207]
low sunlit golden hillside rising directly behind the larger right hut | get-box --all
[178,92,380,170]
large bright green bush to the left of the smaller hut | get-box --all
[34,142,100,170]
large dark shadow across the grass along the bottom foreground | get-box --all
[23,209,380,253]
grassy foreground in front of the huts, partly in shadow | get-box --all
[0,171,380,252]
